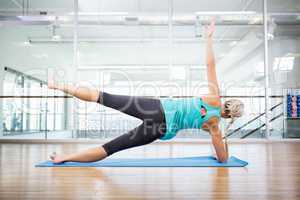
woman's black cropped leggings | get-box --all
[98,92,166,155]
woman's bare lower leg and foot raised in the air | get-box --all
[48,81,100,102]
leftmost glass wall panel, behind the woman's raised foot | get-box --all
[0,0,74,139]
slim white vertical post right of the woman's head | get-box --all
[263,0,270,139]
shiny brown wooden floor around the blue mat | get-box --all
[0,142,300,200]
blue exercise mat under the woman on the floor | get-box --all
[35,156,248,167]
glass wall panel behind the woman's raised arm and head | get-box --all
[173,0,265,138]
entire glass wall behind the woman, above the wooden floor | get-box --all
[0,0,300,141]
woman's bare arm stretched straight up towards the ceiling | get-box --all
[206,20,219,96]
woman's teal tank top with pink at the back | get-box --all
[160,97,221,140]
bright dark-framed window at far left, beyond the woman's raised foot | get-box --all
[3,70,66,135]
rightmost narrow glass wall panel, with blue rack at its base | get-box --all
[268,0,300,138]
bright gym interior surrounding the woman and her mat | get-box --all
[0,0,300,200]
